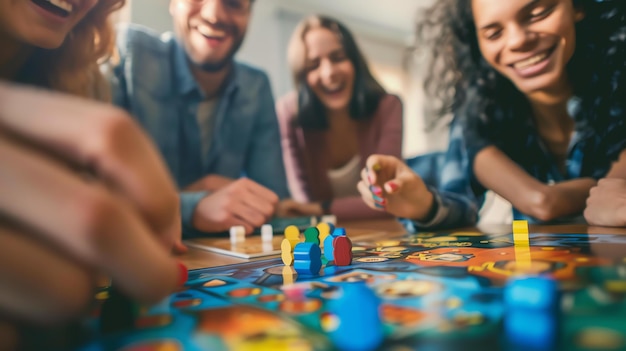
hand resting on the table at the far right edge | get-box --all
[584,178,626,227]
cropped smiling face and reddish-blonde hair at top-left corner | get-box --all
[0,0,125,99]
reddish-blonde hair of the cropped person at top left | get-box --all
[33,0,126,100]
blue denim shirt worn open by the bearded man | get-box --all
[111,25,289,234]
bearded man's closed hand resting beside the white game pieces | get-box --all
[193,178,278,235]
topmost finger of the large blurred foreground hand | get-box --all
[0,84,180,249]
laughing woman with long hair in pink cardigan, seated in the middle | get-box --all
[276,15,402,220]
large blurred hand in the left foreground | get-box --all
[0,83,186,332]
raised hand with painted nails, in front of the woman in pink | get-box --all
[357,155,434,220]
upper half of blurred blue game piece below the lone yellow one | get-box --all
[504,277,559,312]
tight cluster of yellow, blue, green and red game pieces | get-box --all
[280,222,352,275]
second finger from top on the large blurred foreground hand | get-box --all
[0,139,181,302]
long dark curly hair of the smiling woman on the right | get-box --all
[414,0,626,170]
